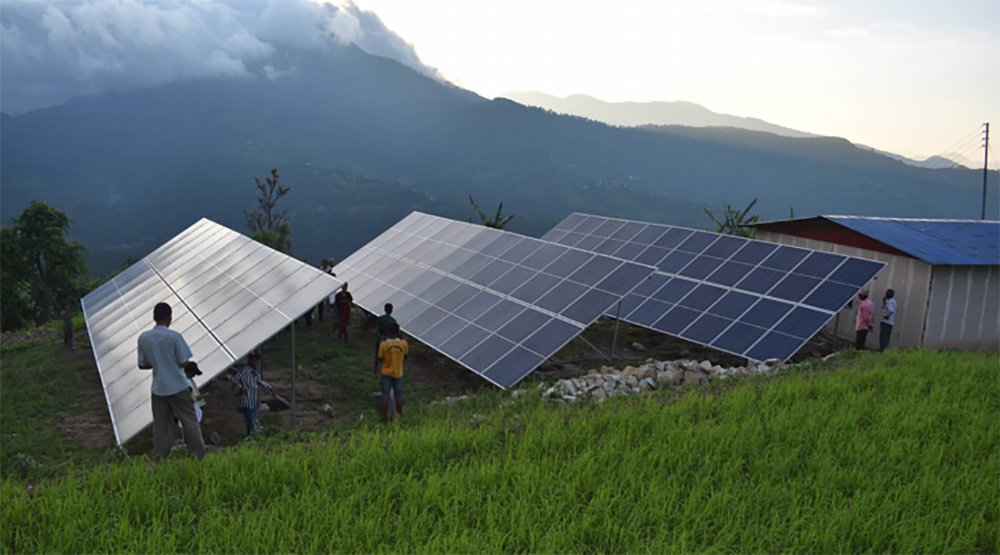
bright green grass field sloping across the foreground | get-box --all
[0,351,1000,553]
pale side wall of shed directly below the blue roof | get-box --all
[924,266,1000,352]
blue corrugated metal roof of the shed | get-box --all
[822,216,1000,266]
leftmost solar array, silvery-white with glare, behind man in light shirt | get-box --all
[81,219,341,445]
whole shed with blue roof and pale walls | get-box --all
[757,216,1000,351]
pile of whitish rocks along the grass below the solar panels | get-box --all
[542,359,784,403]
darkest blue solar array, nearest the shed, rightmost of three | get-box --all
[542,213,884,360]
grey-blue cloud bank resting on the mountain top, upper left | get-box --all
[0,0,440,113]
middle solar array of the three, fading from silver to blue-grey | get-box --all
[334,212,655,388]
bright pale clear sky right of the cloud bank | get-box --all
[357,0,1000,161]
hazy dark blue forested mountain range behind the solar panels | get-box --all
[0,45,996,273]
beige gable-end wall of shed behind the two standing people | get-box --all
[756,230,932,349]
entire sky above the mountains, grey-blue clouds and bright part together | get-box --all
[0,0,1000,161]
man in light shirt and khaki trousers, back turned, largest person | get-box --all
[138,303,205,459]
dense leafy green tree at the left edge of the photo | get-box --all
[0,201,87,329]
